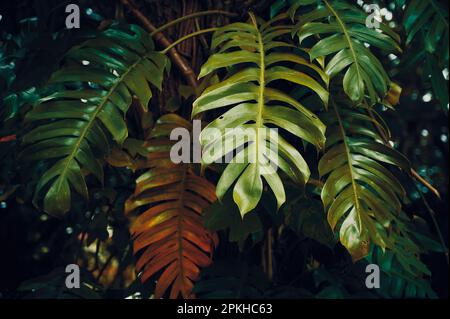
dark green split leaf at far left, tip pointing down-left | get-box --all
[23,25,167,215]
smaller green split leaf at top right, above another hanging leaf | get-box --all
[294,0,401,104]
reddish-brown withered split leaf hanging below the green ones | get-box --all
[125,114,217,298]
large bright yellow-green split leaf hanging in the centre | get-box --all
[192,14,328,215]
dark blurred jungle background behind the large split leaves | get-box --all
[0,0,449,298]
